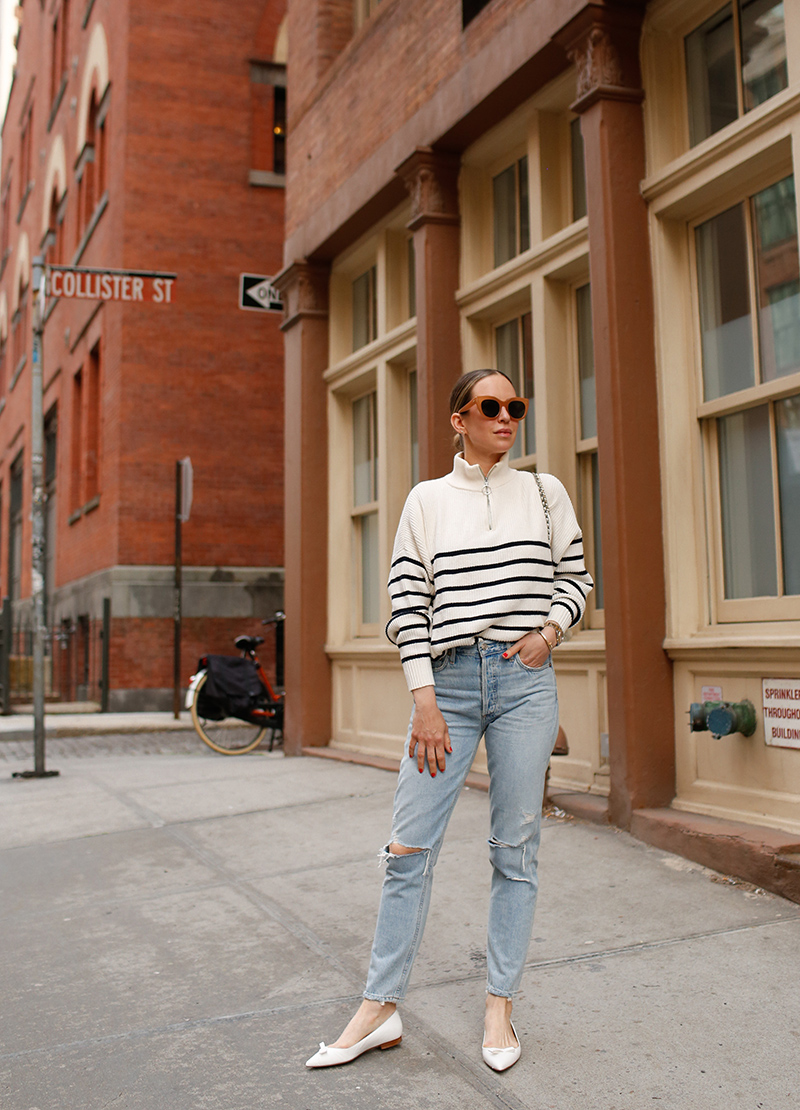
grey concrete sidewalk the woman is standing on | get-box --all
[0,737,800,1110]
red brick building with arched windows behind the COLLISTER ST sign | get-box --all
[0,0,286,708]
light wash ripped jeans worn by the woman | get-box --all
[364,639,558,1002]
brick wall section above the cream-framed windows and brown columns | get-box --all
[286,0,581,245]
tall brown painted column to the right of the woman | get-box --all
[558,3,675,827]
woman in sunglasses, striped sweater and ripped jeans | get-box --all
[307,370,593,1071]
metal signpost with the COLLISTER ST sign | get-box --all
[13,254,178,778]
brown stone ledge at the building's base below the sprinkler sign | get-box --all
[630,809,800,902]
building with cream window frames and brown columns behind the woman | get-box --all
[279,0,800,897]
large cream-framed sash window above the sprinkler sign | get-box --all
[695,176,800,599]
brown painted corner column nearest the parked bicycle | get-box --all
[275,261,331,756]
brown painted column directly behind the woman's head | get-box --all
[396,147,462,480]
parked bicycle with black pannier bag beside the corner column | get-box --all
[185,613,285,756]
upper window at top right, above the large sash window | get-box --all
[686,0,789,147]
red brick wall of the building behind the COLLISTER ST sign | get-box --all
[0,0,285,705]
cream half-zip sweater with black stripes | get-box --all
[386,455,593,689]
